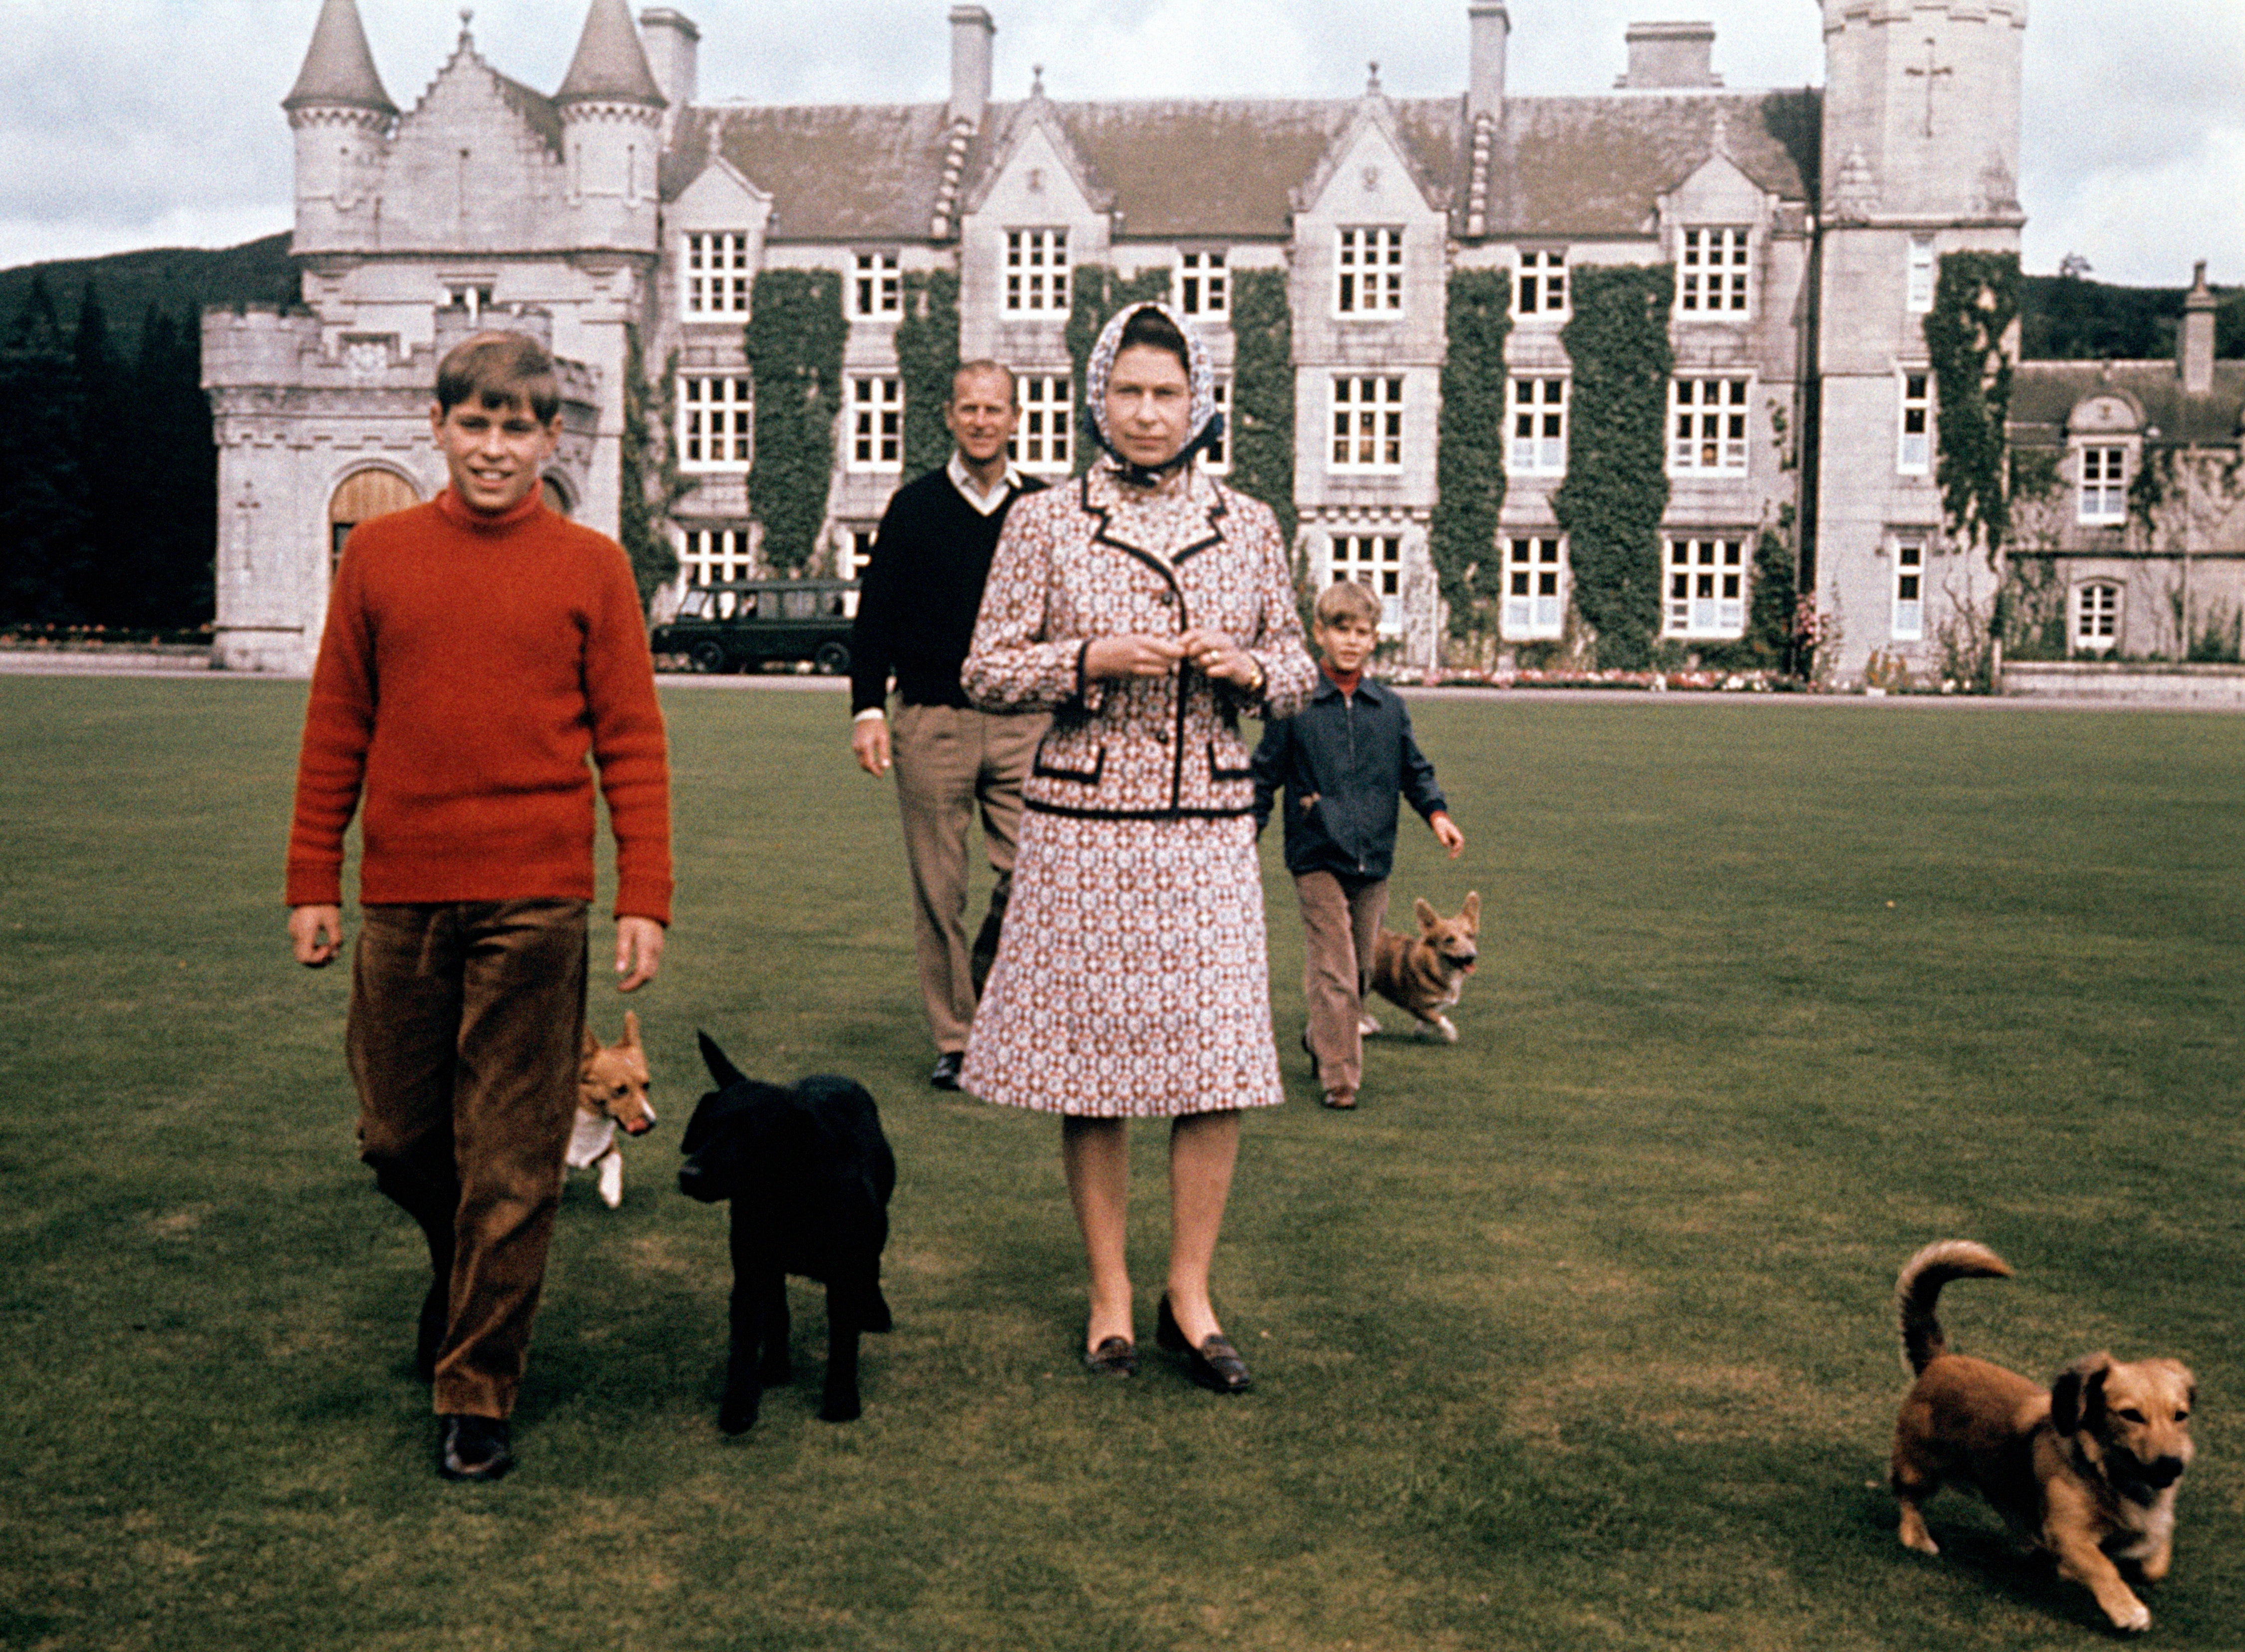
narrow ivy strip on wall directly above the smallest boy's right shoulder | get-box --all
[1426,269,1513,638]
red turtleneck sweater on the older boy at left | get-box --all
[287,489,672,923]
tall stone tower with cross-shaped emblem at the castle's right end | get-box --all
[1809,0,2027,680]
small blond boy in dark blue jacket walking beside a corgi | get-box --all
[1255,581,1466,1107]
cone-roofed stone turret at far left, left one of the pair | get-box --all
[281,0,398,253]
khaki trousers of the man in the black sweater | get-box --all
[889,705,1051,1055]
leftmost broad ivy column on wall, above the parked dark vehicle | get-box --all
[745,269,849,575]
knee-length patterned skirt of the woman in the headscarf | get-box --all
[959,810,1284,1118]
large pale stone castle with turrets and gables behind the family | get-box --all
[205,0,2234,680]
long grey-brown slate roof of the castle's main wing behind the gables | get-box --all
[665,90,1821,240]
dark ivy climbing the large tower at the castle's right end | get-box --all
[1926,251,2020,554]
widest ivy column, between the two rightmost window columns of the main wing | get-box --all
[1552,265,1675,671]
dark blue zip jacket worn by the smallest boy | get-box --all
[1253,671,1448,880]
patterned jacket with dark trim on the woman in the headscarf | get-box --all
[961,469,1318,819]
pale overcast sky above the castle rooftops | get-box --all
[0,0,2245,285]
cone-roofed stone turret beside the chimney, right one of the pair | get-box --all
[555,0,667,253]
